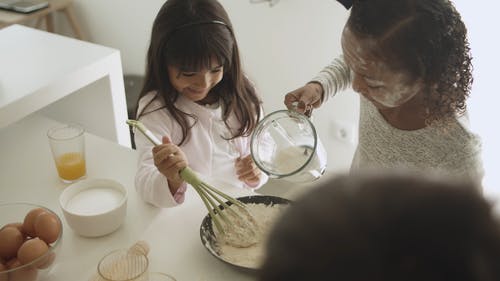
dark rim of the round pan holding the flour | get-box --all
[200,195,291,273]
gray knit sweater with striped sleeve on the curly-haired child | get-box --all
[313,57,484,182]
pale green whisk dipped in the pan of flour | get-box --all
[127,119,258,248]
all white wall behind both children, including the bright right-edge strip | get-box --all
[53,0,500,194]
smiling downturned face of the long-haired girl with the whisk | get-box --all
[168,59,224,102]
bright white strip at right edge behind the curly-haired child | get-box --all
[454,0,500,198]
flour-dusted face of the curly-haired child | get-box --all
[342,26,423,109]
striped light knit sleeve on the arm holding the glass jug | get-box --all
[311,55,352,102]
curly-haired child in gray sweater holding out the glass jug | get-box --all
[285,0,483,182]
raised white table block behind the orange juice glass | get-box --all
[0,25,131,147]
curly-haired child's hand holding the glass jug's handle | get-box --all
[284,82,323,116]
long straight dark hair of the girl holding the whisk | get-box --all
[137,0,261,144]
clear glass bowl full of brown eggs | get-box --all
[0,203,63,281]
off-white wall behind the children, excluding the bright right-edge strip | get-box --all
[58,0,358,175]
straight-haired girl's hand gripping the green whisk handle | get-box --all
[153,137,188,193]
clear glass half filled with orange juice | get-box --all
[47,123,87,183]
